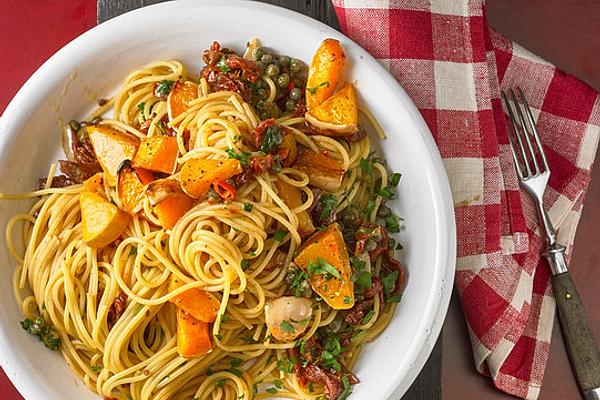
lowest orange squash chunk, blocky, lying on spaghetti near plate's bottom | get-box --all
[177,308,212,358]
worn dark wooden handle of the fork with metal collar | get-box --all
[546,246,600,400]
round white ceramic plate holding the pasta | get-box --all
[0,1,455,400]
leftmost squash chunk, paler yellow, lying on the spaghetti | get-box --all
[79,192,131,248]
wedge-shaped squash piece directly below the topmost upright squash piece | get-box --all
[305,83,358,136]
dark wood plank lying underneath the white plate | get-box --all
[98,0,442,400]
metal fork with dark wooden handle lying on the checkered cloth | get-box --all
[502,88,600,400]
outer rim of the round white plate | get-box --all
[0,0,456,399]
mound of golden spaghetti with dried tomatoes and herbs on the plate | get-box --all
[0,38,403,400]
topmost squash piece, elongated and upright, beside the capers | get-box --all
[306,39,346,111]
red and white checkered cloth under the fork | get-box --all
[333,0,600,399]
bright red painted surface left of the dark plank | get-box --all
[0,0,96,400]
